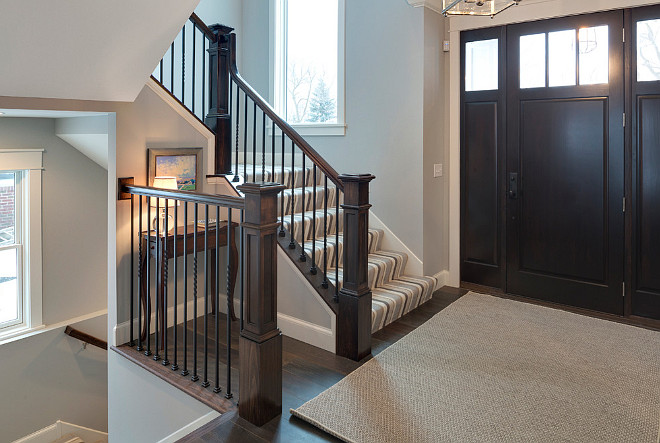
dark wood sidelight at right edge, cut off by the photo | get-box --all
[631,6,660,319]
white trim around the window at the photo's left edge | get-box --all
[0,149,44,341]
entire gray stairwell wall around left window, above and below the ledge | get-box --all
[0,117,108,442]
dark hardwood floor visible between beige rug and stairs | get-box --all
[179,286,467,443]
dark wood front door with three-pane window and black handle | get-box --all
[505,11,624,314]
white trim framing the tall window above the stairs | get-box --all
[269,0,346,136]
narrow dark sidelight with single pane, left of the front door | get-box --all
[461,28,506,288]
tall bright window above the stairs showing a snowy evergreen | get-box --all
[274,0,344,135]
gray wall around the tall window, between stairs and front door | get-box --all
[235,0,448,274]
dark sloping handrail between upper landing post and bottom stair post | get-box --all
[229,33,344,191]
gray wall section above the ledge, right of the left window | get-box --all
[0,118,108,325]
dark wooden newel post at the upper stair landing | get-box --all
[209,24,234,175]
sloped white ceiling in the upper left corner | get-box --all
[0,0,199,102]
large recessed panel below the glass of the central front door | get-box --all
[518,99,607,283]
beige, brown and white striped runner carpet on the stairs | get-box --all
[239,165,437,333]
